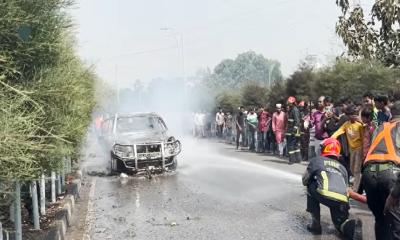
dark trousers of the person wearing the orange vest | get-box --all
[362,169,400,240]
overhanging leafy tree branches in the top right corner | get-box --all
[336,0,400,66]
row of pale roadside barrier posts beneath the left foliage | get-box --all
[0,157,72,240]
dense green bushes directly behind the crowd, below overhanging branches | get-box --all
[276,60,400,101]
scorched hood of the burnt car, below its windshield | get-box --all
[115,131,168,145]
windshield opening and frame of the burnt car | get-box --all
[115,115,167,134]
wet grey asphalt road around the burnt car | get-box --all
[69,136,373,240]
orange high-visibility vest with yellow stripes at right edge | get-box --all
[364,121,400,165]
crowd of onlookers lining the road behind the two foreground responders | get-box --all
[199,92,391,169]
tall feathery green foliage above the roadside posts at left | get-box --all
[0,0,96,226]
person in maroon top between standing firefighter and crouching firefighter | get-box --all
[311,96,328,156]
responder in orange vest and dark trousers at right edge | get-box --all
[362,101,400,240]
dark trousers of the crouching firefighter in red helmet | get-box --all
[307,185,350,232]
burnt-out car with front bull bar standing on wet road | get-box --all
[102,113,181,173]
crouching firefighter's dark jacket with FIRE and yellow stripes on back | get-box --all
[303,156,349,203]
